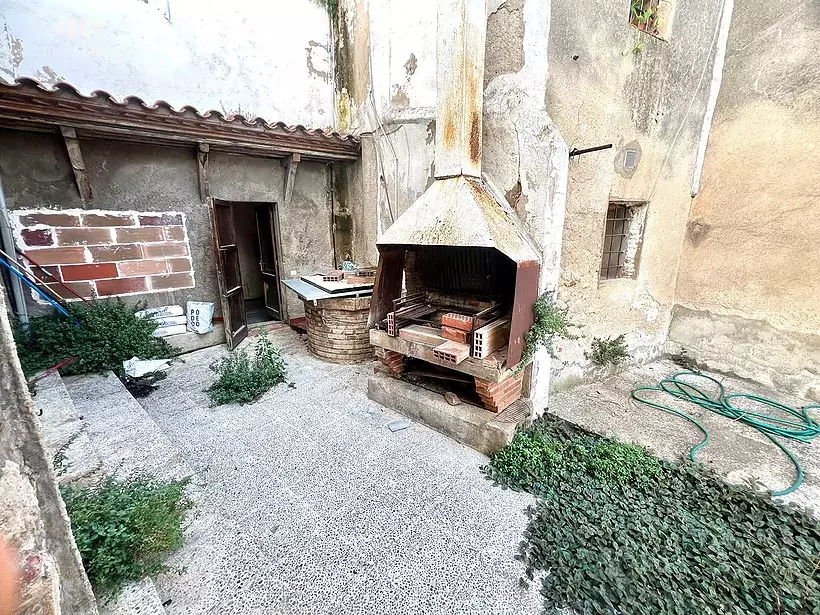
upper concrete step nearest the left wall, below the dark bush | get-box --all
[34,372,102,485]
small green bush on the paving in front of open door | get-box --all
[206,333,287,406]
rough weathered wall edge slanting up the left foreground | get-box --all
[0,292,97,615]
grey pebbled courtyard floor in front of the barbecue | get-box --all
[140,329,541,615]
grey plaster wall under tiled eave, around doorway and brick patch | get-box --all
[0,131,333,317]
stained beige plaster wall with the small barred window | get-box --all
[544,0,721,387]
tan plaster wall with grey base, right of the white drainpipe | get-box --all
[669,0,820,399]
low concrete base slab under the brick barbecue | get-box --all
[367,373,530,455]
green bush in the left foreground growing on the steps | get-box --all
[60,475,193,597]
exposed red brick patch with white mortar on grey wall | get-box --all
[13,210,194,300]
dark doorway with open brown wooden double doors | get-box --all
[211,199,282,348]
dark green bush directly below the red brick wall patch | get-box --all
[14,299,173,377]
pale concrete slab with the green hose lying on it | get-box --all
[549,361,820,511]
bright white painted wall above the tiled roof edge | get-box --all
[0,0,335,128]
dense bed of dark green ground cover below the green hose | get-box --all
[484,418,820,615]
